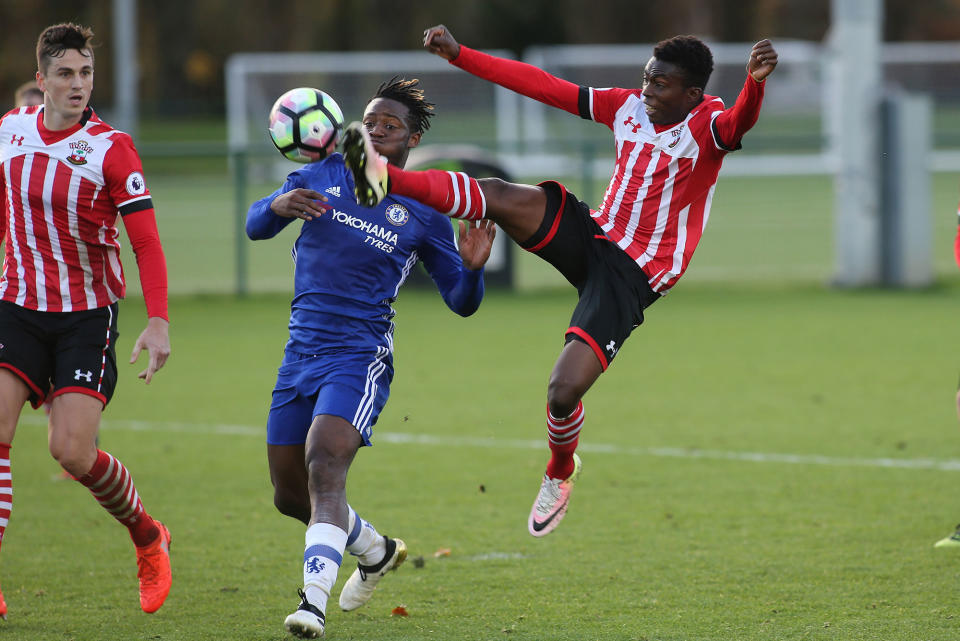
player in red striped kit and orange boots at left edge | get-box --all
[0,24,171,616]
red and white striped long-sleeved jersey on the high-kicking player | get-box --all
[451,45,764,294]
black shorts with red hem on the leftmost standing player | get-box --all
[0,301,118,408]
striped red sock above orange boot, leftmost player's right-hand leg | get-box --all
[77,450,160,547]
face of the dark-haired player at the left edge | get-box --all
[37,49,93,129]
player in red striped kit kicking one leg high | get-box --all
[344,25,777,536]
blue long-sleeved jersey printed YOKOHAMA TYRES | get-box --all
[247,153,483,354]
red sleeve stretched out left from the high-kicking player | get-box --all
[450,45,591,119]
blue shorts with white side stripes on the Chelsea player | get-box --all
[267,347,393,445]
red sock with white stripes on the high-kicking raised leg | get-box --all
[387,165,487,220]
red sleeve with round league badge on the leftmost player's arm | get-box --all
[103,138,168,320]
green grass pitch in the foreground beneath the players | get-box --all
[0,282,960,641]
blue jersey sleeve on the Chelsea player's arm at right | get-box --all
[419,214,483,316]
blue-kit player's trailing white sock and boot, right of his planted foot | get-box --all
[340,506,407,611]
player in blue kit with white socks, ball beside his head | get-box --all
[247,78,495,639]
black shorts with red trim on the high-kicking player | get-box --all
[522,182,660,370]
